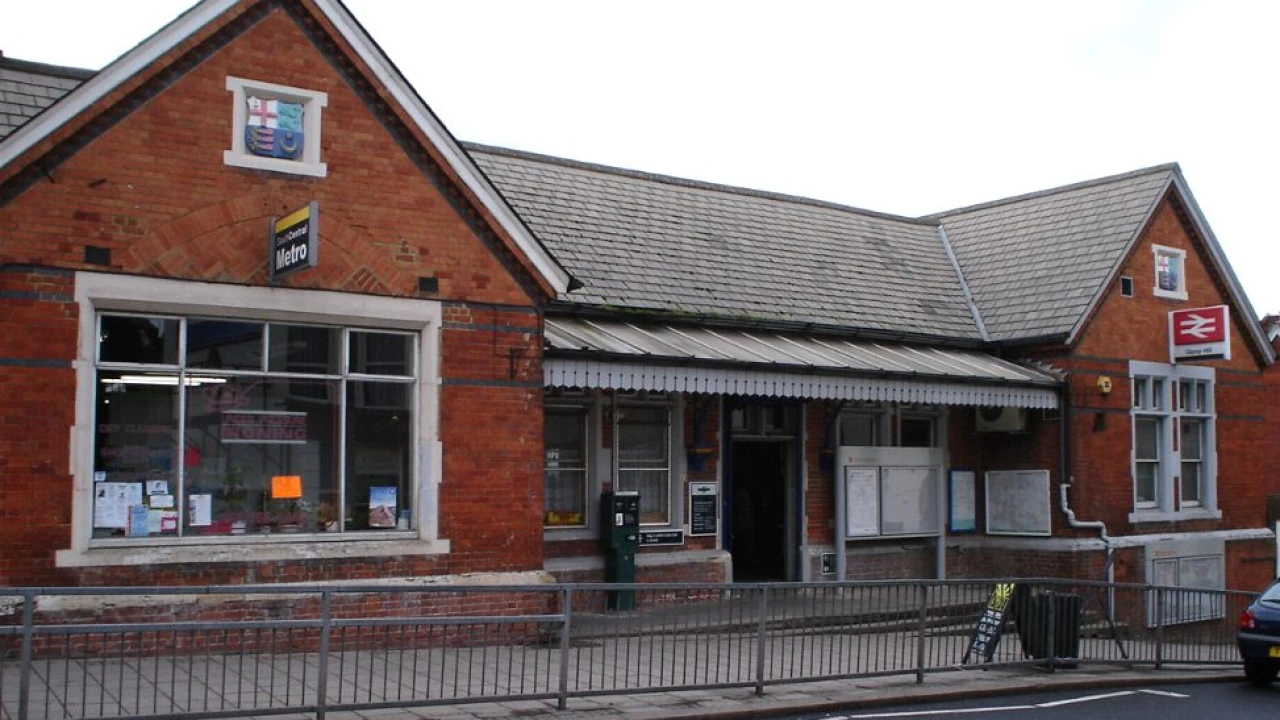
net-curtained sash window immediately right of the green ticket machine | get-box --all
[613,405,671,525]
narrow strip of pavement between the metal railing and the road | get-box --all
[299,665,1244,720]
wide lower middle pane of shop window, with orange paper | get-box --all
[183,375,340,536]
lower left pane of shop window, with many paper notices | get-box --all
[93,372,179,538]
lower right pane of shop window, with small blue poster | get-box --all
[346,380,413,530]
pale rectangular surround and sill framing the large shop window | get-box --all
[56,272,449,568]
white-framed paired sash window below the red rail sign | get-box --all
[1130,361,1216,520]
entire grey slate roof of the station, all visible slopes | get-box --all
[0,56,1265,353]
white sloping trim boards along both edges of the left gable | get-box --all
[0,0,570,293]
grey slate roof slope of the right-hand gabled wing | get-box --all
[933,164,1178,341]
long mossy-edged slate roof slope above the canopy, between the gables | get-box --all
[466,145,980,341]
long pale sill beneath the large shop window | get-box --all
[58,530,449,568]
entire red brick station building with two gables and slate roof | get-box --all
[0,0,1280,597]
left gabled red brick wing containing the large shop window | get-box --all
[0,0,570,584]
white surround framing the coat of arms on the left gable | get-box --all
[223,77,329,178]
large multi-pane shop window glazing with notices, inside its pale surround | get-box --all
[92,314,419,542]
